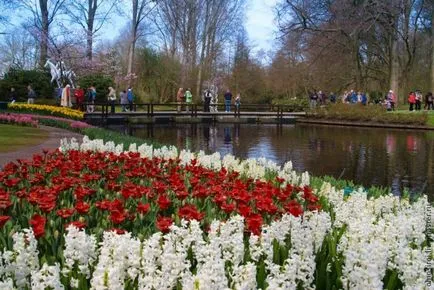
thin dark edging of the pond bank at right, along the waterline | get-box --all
[297,118,434,131]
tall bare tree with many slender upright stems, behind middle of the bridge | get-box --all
[156,0,245,95]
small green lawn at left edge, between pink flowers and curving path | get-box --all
[0,124,49,153]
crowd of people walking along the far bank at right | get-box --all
[309,90,434,111]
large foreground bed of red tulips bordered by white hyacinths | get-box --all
[0,138,432,289]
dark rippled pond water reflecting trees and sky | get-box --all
[111,124,434,197]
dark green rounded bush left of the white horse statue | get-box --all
[0,68,54,101]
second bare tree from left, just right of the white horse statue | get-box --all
[64,0,118,61]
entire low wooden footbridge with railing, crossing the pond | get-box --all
[83,103,305,124]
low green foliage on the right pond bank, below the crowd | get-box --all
[307,104,428,126]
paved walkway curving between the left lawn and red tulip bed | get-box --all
[0,126,83,169]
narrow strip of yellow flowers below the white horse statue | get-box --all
[8,103,84,120]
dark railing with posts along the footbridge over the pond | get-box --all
[83,103,302,118]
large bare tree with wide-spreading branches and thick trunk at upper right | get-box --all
[278,0,426,103]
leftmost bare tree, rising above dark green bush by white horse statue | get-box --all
[19,0,66,67]
